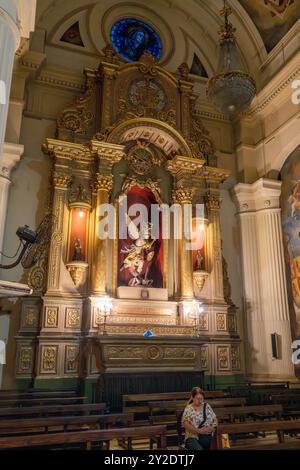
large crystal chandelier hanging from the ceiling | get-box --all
[207,0,256,116]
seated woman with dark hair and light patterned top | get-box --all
[182,387,218,450]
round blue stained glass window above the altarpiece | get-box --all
[110,18,162,62]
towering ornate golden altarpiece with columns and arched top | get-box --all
[16,46,242,392]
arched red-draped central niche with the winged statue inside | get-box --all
[118,186,163,288]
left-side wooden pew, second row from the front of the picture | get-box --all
[0,413,134,435]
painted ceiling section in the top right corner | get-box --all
[239,0,300,52]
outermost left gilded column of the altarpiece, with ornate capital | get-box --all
[47,172,72,295]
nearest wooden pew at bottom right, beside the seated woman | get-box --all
[216,420,300,449]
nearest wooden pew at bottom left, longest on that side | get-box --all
[0,426,166,450]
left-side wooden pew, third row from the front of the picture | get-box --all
[0,403,106,420]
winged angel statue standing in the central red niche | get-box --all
[120,216,156,287]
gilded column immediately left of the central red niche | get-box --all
[92,174,113,295]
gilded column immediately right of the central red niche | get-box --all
[173,188,194,300]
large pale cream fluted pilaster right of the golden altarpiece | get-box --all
[234,179,294,381]
